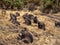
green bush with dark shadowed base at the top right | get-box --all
[40,0,60,13]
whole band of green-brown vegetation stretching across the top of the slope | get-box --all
[0,0,60,13]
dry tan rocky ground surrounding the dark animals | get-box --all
[0,10,60,45]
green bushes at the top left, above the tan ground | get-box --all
[1,0,24,9]
